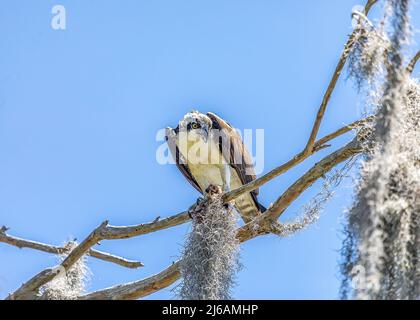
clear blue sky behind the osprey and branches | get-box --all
[0,0,420,299]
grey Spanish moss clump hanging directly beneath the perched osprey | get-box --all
[176,186,239,300]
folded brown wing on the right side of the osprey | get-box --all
[207,112,260,208]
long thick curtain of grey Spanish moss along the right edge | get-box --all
[341,0,420,299]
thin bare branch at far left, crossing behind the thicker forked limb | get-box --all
[0,226,144,269]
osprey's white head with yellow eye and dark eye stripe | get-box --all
[179,110,212,142]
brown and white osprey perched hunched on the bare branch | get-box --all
[166,111,266,222]
